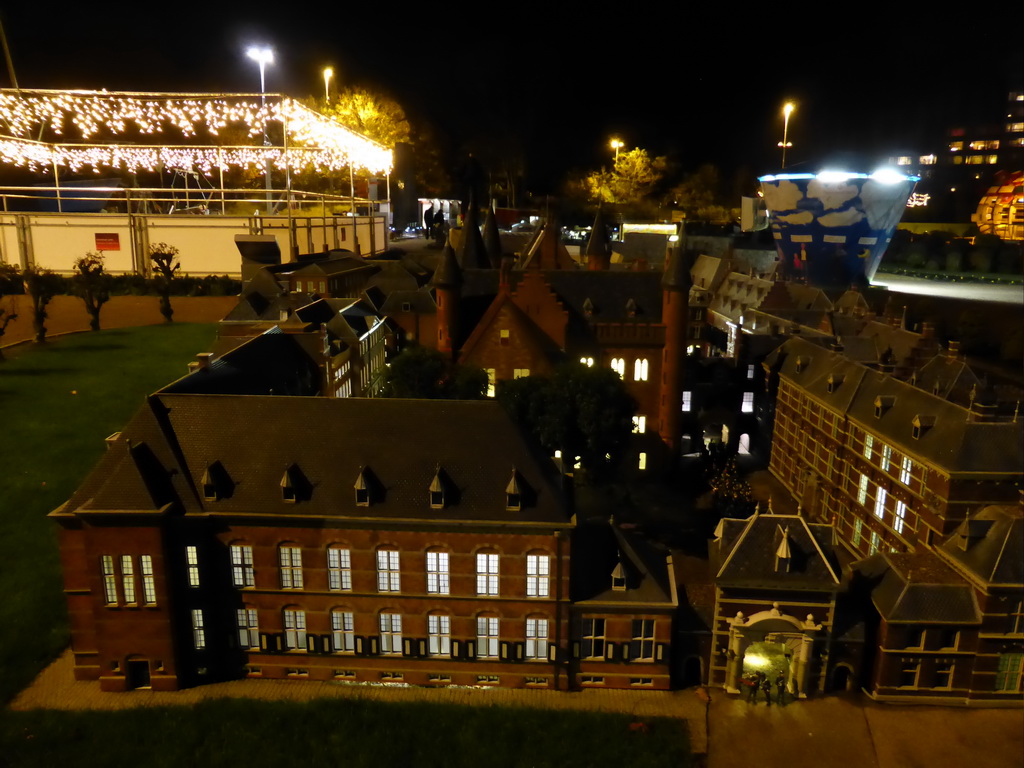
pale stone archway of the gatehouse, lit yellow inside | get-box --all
[724,603,821,698]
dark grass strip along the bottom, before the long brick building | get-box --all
[0,694,690,768]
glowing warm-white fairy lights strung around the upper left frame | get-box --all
[0,89,393,174]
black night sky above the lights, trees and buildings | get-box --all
[0,2,1024,191]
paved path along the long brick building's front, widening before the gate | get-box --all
[11,651,1024,768]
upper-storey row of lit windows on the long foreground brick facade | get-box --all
[223,544,551,598]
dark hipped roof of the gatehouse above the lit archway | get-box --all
[715,513,840,591]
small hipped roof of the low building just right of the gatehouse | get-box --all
[869,551,981,624]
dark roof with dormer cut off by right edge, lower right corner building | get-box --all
[940,505,1024,587]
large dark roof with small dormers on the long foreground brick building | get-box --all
[67,392,570,527]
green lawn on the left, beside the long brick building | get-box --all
[0,324,216,704]
